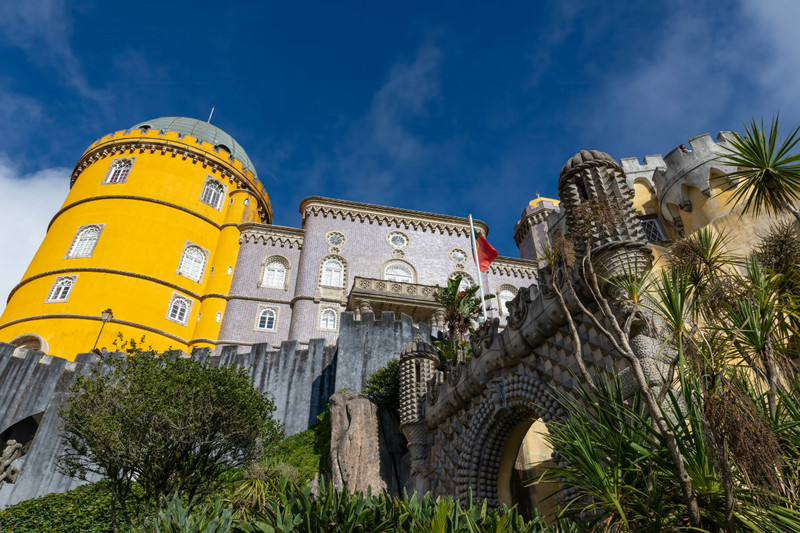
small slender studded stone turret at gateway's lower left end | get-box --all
[400,335,441,493]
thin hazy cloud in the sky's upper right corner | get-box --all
[576,0,800,156]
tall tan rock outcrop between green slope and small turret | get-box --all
[329,393,408,495]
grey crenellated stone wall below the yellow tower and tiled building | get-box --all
[0,312,431,508]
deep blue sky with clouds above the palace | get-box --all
[0,0,800,309]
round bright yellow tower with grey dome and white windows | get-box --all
[0,117,272,359]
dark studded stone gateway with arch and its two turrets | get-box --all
[400,151,662,506]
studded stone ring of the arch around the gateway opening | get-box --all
[456,374,553,507]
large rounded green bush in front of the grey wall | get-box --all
[59,352,282,523]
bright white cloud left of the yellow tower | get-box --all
[0,155,70,312]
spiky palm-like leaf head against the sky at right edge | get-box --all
[719,117,800,222]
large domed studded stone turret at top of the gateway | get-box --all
[558,150,653,294]
